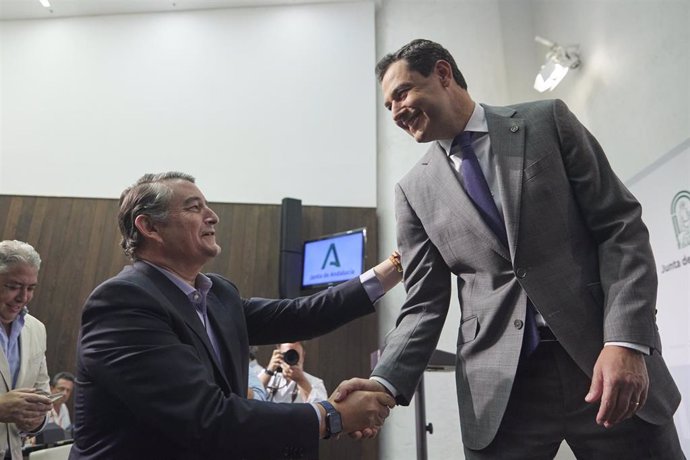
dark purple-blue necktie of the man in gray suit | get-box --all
[453,131,539,359]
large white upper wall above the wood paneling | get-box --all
[0,2,376,207]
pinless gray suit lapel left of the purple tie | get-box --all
[421,142,510,259]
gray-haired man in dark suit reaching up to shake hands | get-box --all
[70,173,400,460]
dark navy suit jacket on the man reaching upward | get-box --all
[70,262,373,460]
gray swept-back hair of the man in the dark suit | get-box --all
[117,171,194,259]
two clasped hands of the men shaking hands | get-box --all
[318,378,395,439]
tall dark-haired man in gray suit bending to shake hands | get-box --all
[339,40,684,459]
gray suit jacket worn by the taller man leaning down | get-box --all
[373,101,680,449]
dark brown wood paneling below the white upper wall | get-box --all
[0,195,378,460]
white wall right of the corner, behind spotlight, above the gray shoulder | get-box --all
[520,0,690,180]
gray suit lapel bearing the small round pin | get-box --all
[484,106,525,254]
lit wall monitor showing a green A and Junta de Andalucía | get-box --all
[302,228,367,289]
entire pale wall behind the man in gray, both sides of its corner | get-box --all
[376,0,690,460]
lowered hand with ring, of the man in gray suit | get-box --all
[585,346,649,428]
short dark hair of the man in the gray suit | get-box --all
[376,38,467,89]
